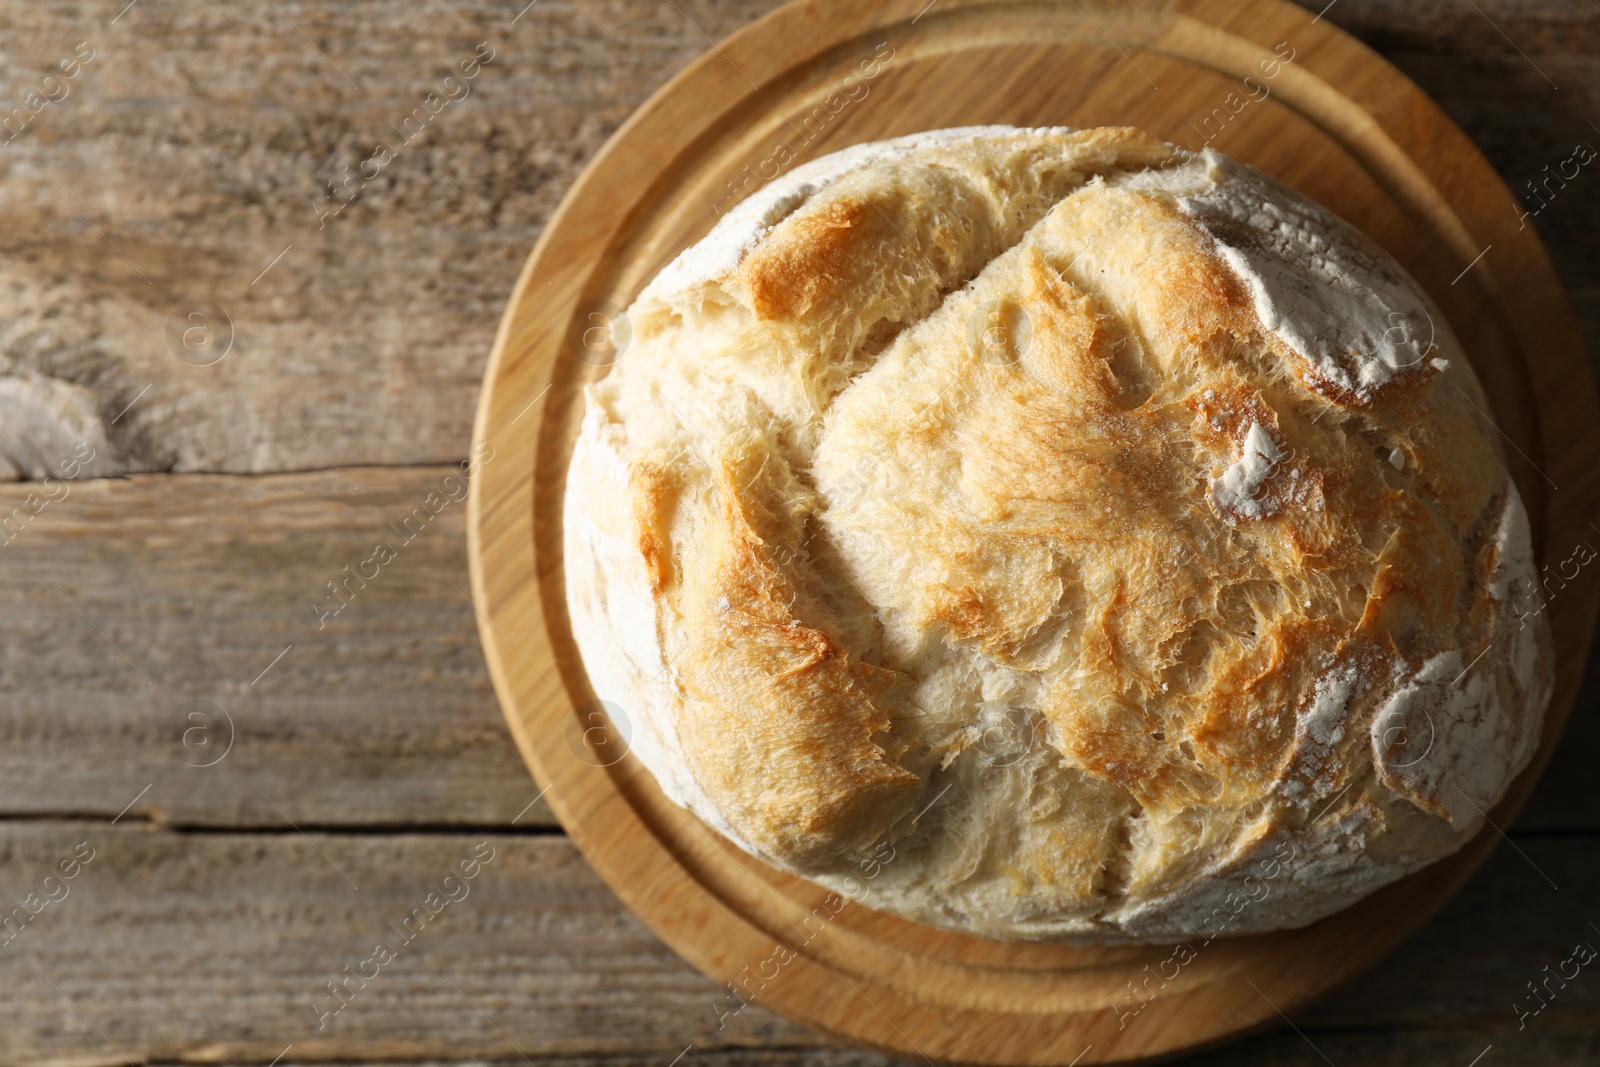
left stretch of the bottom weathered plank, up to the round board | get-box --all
[0,824,814,1064]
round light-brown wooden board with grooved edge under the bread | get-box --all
[469,0,1600,1064]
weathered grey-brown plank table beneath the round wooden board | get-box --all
[0,0,1600,1067]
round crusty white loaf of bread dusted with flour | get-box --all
[563,126,1552,942]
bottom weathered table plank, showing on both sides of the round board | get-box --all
[0,821,1600,1067]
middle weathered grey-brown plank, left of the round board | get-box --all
[0,467,549,827]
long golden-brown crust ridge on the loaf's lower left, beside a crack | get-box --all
[667,454,922,865]
